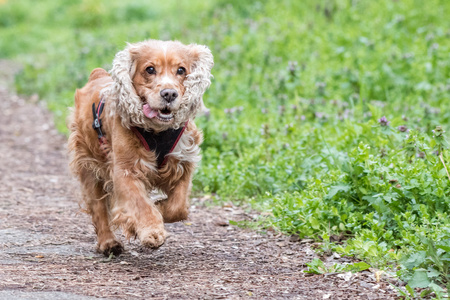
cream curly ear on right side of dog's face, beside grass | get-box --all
[183,44,214,115]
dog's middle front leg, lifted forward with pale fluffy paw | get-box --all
[113,166,166,248]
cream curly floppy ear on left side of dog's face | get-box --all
[110,44,144,128]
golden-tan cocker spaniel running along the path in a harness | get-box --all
[68,40,214,256]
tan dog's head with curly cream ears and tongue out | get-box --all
[104,40,214,131]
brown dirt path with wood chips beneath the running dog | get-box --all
[0,62,395,299]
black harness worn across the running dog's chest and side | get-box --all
[92,99,189,168]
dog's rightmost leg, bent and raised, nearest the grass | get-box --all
[156,173,191,223]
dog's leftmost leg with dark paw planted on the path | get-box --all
[81,171,123,256]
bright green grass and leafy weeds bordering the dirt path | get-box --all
[0,0,450,297]
